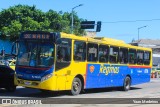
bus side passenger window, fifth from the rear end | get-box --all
[109,47,119,63]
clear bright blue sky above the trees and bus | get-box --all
[0,0,160,43]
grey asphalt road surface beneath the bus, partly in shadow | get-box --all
[0,79,160,107]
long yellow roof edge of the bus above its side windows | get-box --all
[61,33,152,51]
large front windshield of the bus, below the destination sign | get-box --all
[17,41,55,67]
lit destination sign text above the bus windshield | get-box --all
[22,34,50,39]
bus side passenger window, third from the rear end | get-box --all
[128,49,136,64]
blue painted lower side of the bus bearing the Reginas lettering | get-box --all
[86,64,151,89]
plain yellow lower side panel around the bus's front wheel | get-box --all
[56,62,86,90]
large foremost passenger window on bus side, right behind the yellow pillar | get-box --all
[73,41,86,61]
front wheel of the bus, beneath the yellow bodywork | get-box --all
[71,77,82,95]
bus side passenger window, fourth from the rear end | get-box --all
[119,48,128,64]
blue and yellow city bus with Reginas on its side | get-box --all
[15,31,152,95]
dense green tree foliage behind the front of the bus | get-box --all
[0,5,84,40]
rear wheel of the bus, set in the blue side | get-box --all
[122,76,131,91]
